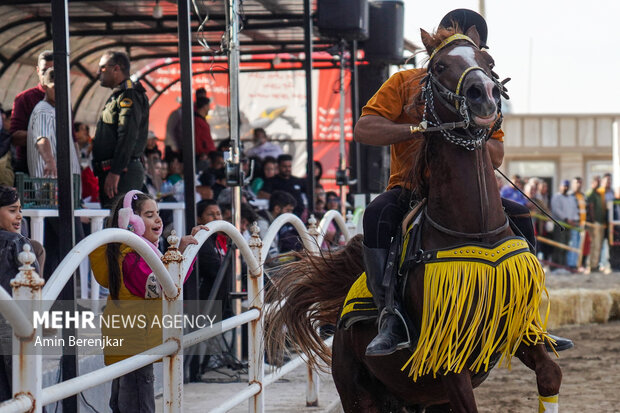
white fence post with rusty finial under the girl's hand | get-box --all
[162,231,185,413]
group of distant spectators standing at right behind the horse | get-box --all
[498,173,615,272]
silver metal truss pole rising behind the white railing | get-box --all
[226,0,243,360]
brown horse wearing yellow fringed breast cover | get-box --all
[265,27,562,412]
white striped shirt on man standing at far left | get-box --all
[26,100,81,178]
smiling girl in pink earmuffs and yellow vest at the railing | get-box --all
[90,191,207,413]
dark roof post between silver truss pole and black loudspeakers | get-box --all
[304,0,315,211]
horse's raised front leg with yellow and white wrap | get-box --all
[517,344,562,413]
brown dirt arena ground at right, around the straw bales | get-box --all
[476,273,620,413]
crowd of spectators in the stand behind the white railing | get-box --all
[0,51,339,411]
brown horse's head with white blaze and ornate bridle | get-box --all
[421,26,503,145]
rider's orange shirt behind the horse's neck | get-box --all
[362,69,504,189]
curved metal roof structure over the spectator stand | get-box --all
[0,0,344,123]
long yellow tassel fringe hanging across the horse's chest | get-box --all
[401,252,549,381]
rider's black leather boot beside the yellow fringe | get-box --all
[364,245,409,356]
